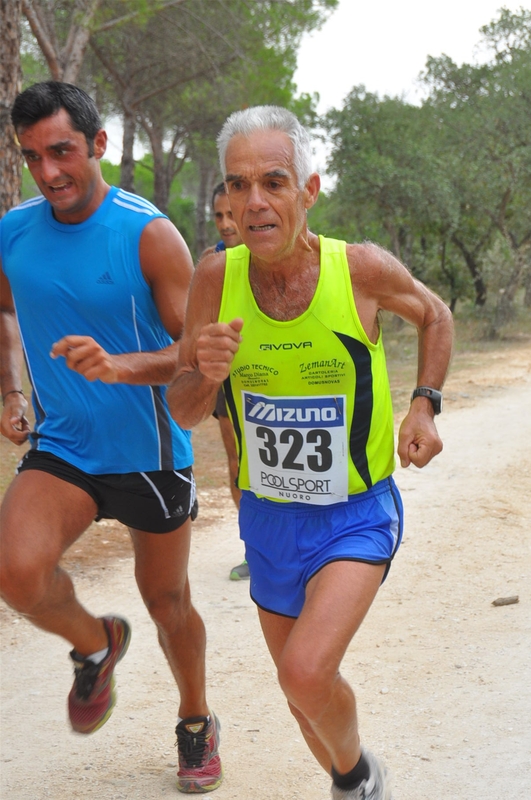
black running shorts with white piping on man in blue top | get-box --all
[17,450,197,533]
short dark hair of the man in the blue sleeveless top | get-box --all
[11,81,102,157]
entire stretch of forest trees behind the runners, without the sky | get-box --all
[0,0,531,340]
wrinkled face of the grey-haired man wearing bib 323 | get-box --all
[225,130,319,261]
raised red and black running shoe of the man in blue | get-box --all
[68,617,131,733]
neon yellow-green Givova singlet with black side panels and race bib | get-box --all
[219,236,394,505]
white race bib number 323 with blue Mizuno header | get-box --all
[242,390,348,505]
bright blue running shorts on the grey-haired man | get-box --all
[239,477,403,617]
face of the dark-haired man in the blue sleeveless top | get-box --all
[17,108,107,223]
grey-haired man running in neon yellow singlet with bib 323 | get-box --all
[168,106,452,800]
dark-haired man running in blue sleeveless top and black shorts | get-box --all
[0,81,222,792]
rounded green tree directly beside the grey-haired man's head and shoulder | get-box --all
[325,86,457,304]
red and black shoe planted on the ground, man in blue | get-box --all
[175,712,223,794]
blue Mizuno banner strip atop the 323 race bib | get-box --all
[244,392,345,428]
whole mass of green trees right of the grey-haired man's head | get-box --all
[324,9,531,328]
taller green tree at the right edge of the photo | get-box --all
[426,9,531,336]
